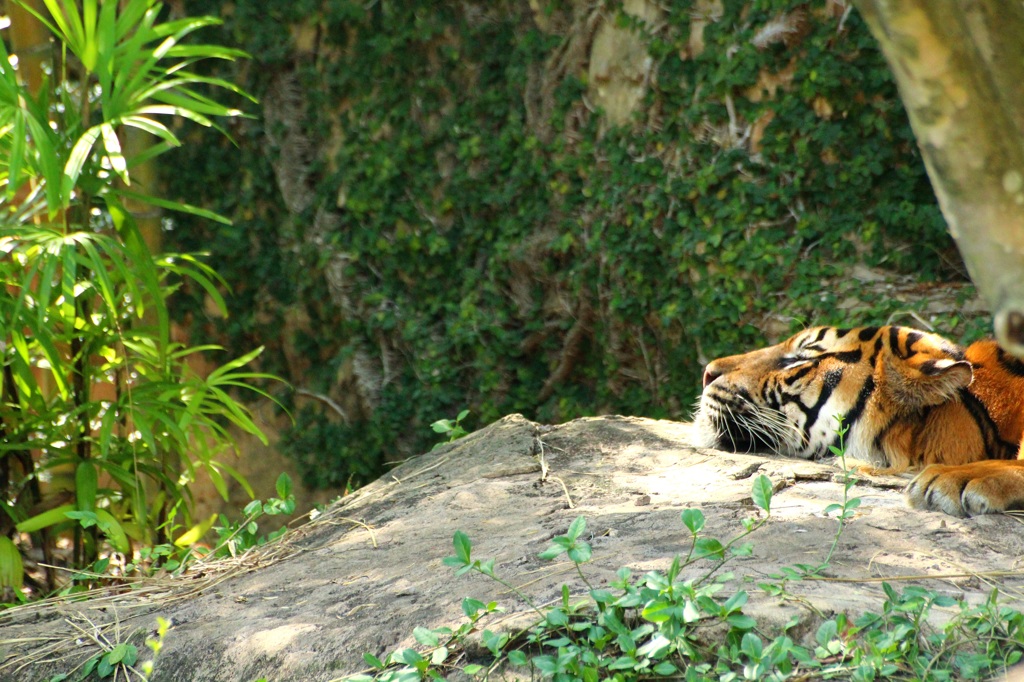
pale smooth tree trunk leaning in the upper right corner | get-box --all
[854,0,1024,356]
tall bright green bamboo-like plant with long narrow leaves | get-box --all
[0,0,270,588]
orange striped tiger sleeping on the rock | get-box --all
[694,326,1024,517]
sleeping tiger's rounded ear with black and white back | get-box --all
[884,354,974,410]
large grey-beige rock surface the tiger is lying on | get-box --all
[0,416,1024,682]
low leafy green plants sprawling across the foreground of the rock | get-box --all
[343,466,1024,682]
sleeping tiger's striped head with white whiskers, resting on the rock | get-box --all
[694,327,973,466]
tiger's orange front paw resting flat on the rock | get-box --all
[906,460,1024,516]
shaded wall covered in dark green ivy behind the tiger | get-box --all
[165,0,959,485]
